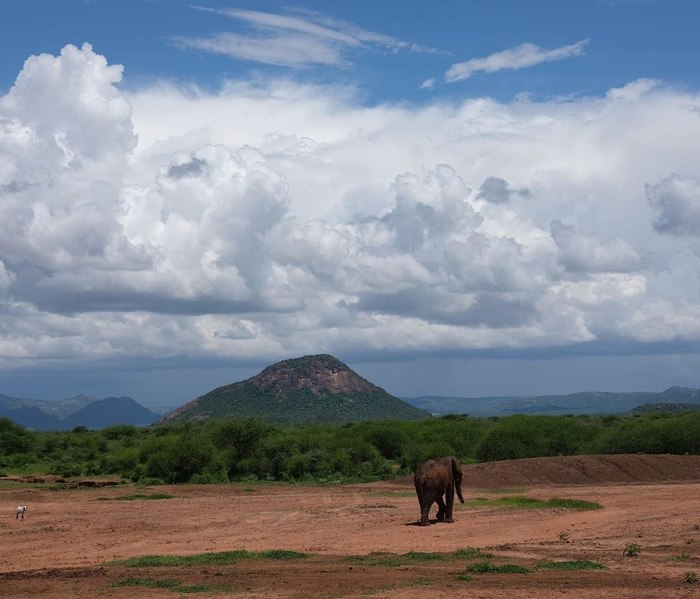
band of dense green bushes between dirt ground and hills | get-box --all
[0,413,700,483]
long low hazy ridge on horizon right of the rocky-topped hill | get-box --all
[402,387,700,416]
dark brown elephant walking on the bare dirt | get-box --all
[413,456,464,526]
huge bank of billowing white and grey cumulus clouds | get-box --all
[0,44,700,367]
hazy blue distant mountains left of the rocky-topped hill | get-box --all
[0,393,161,430]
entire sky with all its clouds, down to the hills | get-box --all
[0,0,700,406]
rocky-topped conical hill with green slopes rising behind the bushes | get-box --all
[161,354,428,424]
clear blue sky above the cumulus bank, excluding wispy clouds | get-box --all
[6,0,700,102]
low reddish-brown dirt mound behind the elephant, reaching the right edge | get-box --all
[393,454,700,489]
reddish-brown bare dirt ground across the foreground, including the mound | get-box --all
[0,456,700,599]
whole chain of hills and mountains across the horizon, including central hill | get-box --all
[5,368,700,430]
